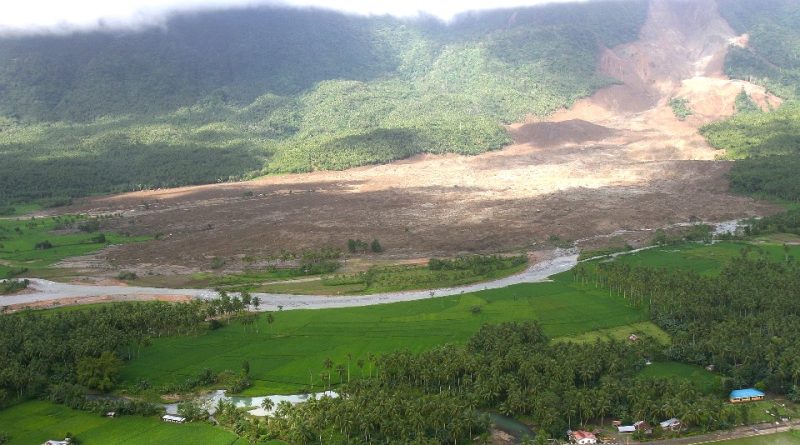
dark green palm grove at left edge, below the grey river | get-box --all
[0,302,208,406]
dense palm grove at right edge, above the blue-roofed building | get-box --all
[576,249,800,394]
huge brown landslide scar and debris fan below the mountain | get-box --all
[66,0,780,270]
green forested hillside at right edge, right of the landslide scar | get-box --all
[702,0,800,201]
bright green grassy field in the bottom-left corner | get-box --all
[0,401,253,445]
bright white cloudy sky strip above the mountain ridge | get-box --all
[0,0,588,34]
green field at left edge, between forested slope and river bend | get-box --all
[0,216,150,278]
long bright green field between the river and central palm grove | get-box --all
[122,274,646,395]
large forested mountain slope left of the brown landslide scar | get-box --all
[0,0,646,202]
